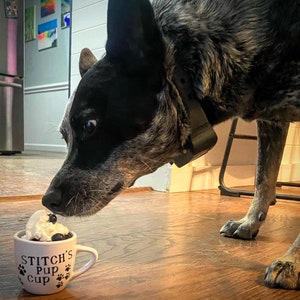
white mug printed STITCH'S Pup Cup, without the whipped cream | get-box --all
[14,230,98,295]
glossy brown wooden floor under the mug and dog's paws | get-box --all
[0,151,300,300]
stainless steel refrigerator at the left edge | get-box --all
[0,0,24,154]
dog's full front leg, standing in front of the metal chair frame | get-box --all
[220,121,289,240]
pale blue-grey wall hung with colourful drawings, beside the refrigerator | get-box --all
[24,0,70,151]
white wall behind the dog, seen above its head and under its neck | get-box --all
[71,0,300,192]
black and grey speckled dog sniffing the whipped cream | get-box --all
[42,0,300,289]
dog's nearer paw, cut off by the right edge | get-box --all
[264,260,300,290]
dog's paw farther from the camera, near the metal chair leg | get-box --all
[220,220,258,240]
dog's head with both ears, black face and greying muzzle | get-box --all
[43,0,188,215]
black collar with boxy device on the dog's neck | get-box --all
[173,65,217,167]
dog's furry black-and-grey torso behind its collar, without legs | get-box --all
[153,0,300,124]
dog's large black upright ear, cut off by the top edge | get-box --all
[106,0,165,89]
